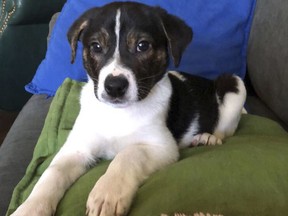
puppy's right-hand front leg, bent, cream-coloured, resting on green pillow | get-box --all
[86,144,178,216]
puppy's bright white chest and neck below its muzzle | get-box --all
[75,77,171,158]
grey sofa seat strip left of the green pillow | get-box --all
[0,95,52,215]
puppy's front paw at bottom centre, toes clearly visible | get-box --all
[86,175,136,216]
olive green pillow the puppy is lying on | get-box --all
[7,79,288,216]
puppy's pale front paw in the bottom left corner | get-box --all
[11,198,55,216]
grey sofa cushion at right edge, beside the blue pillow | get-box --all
[248,0,288,127]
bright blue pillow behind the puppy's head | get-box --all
[25,0,256,96]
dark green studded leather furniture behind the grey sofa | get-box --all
[0,0,66,111]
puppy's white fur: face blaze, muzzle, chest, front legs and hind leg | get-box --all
[12,7,245,216]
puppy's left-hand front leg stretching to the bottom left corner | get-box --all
[12,145,91,216]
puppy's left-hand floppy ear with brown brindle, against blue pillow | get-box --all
[67,11,91,64]
